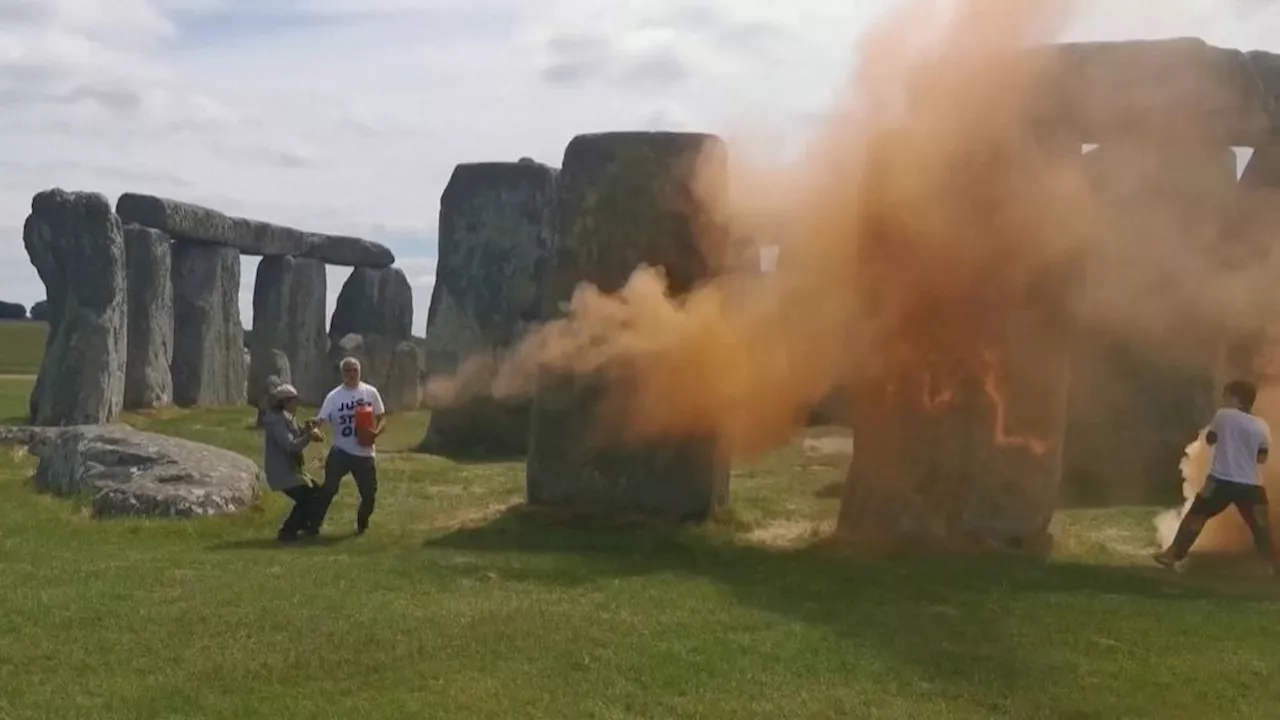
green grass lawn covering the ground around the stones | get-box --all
[0,368,1280,720]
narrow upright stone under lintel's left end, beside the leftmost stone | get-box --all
[124,225,173,410]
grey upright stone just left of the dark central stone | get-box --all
[419,160,556,456]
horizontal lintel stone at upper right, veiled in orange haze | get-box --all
[1046,37,1274,146]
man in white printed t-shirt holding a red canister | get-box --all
[311,357,387,534]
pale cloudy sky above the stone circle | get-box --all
[0,0,1280,334]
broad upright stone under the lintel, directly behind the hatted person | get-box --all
[250,258,332,405]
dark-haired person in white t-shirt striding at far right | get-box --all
[1155,380,1280,573]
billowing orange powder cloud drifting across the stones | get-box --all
[428,0,1280,457]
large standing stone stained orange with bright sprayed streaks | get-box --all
[837,126,1082,553]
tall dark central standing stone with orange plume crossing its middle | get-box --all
[526,132,728,520]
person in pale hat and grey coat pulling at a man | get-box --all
[262,384,323,542]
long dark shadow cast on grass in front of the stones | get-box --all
[425,509,1274,711]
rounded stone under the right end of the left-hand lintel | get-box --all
[329,268,413,342]
